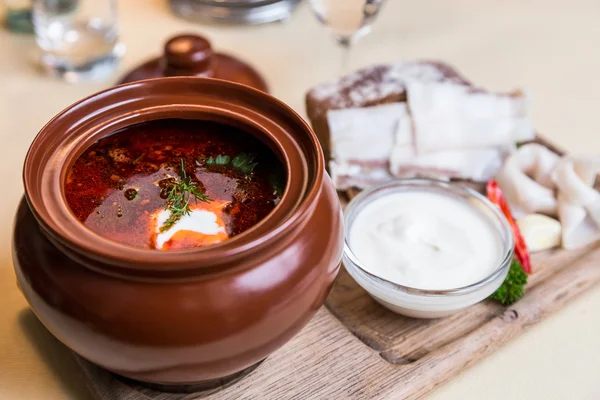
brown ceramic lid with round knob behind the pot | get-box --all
[118,34,268,92]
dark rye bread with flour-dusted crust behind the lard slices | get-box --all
[306,61,470,160]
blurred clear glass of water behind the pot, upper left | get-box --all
[33,0,125,82]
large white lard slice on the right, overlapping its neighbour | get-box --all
[407,80,535,154]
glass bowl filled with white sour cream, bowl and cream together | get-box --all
[344,179,514,318]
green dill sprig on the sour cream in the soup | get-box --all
[160,159,211,232]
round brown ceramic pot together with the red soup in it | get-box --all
[13,77,343,391]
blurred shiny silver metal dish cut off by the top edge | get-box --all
[169,0,300,24]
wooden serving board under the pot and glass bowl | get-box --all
[68,140,600,400]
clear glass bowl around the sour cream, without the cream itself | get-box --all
[343,179,514,318]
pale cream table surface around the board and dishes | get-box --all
[0,0,600,400]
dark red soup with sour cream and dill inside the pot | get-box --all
[65,119,285,250]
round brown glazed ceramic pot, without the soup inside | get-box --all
[14,77,343,385]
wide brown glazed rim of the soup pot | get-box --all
[23,77,324,273]
